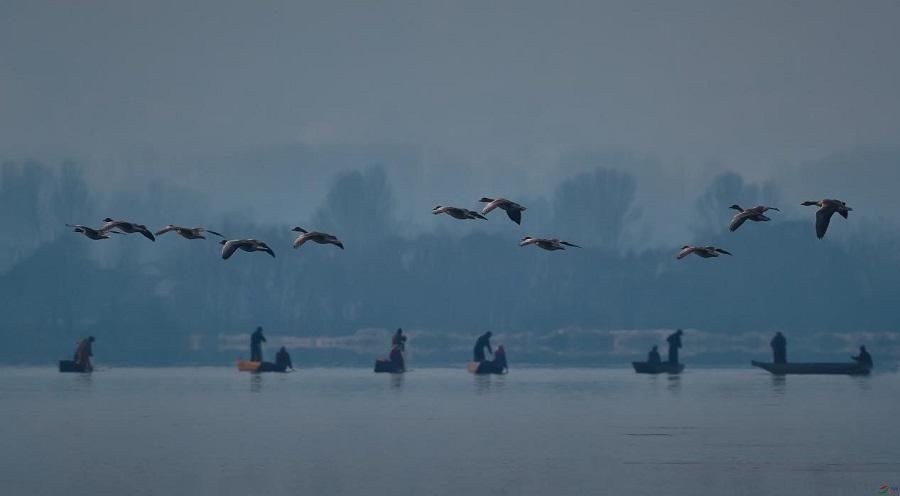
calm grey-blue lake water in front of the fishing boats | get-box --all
[0,367,900,496]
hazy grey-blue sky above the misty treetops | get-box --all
[0,0,900,239]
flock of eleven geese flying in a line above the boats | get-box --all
[66,197,853,260]
